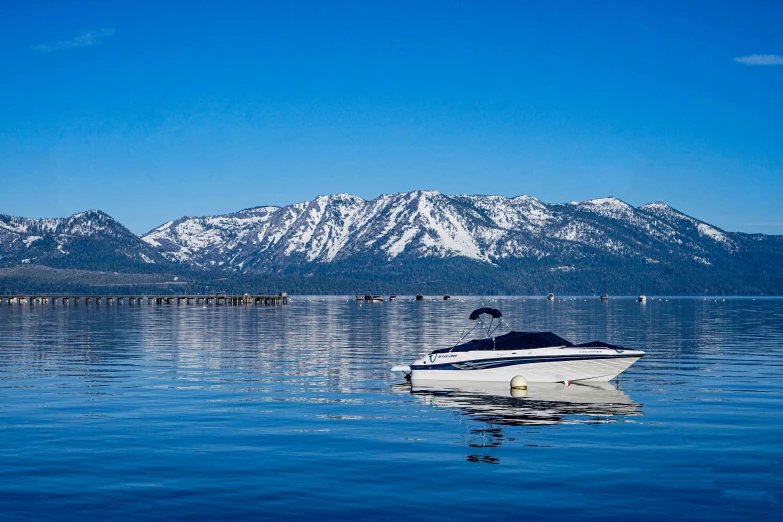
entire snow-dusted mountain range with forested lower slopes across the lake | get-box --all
[0,191,783,295]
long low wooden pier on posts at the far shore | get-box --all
[0,292,288,306]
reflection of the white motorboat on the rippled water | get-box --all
[394,381,642,464]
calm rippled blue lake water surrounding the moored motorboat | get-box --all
[0,298,783,520]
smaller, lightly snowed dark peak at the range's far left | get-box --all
[0,210,172,272]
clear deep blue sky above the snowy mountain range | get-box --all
[0,0,783,234]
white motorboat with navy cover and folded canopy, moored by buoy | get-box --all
[392,307,645,383]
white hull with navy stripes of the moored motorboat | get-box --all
[411,350,644,383]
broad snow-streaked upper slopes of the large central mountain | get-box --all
[142,191,740,273]
